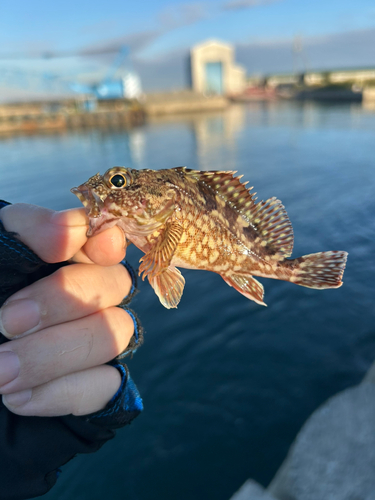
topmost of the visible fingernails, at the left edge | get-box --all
[0,299,40,337]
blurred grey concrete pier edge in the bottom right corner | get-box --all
[231,363,375,500]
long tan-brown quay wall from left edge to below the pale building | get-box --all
[0,91,229,134]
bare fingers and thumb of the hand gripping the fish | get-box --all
[0,204,134,416]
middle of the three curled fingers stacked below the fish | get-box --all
[0,307,134,394]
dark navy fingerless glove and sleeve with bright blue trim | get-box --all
[0,201,143,500]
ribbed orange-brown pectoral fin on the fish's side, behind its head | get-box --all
[139,221,183,279]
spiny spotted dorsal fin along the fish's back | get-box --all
[176,167,293,258]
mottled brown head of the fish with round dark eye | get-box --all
[71,167,174,236]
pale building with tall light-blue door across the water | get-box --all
[190,40,246,96]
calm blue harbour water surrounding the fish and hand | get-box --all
[0,103,375,500]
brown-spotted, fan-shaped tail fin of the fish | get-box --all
[289,251,348,289]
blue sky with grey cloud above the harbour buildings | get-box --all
[0,0,375,96]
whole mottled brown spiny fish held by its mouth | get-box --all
[71,167,348,309]
